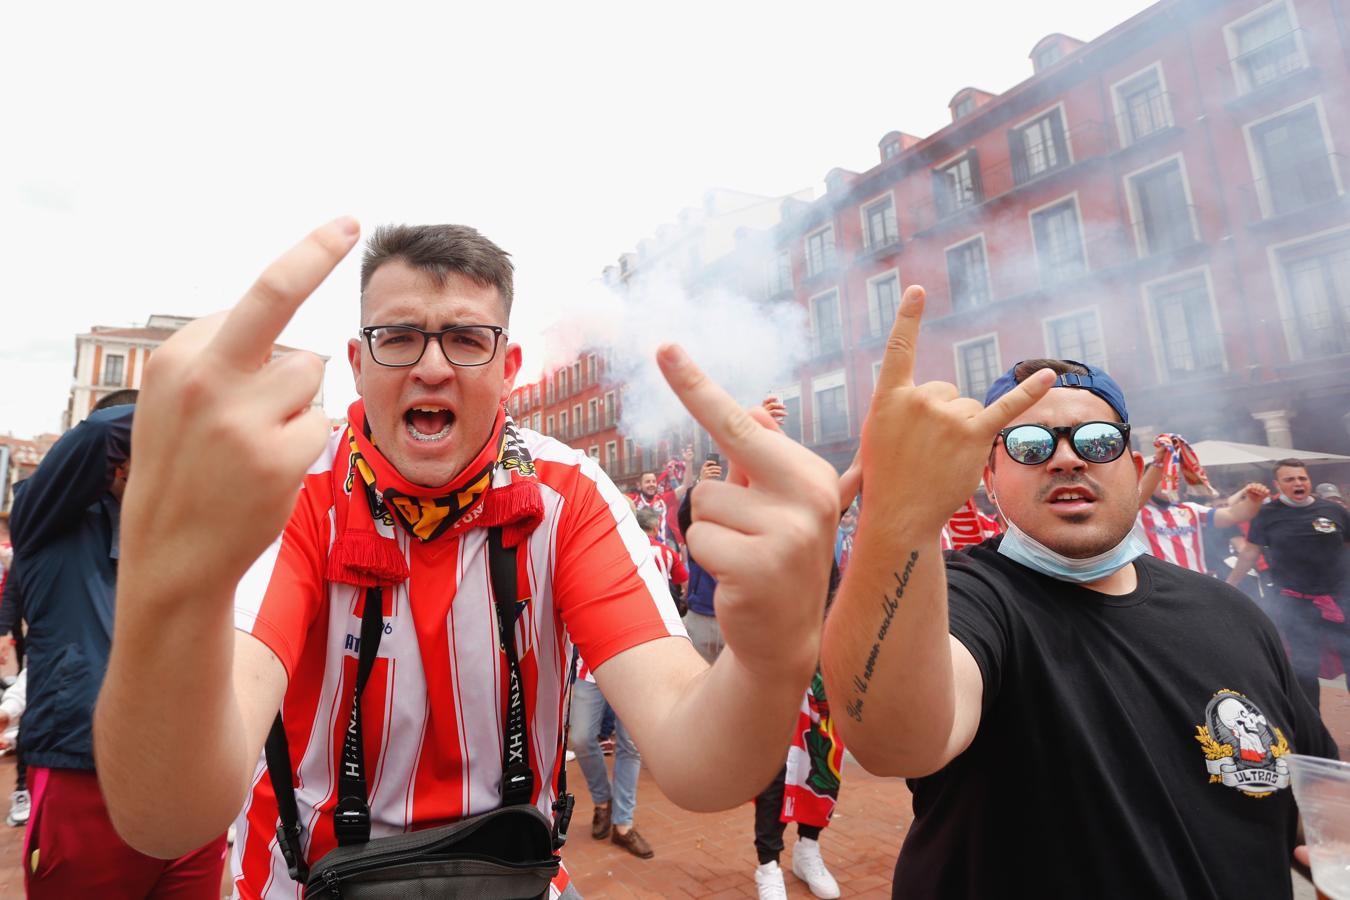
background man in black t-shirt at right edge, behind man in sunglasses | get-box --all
[1229,459,1350,708]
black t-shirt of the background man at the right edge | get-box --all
[1247,498,1350,594]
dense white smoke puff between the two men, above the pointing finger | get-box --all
[544,273,809,447]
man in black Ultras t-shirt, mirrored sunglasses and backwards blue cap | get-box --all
[822,287,1337,900]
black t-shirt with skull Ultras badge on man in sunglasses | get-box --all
[894,538,1337,900]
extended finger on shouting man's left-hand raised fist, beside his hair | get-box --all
[211,216,360,367]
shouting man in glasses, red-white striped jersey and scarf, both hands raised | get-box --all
[96,219,838,897]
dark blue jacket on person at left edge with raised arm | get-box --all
[5,406,135,769]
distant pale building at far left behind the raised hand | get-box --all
[61,316,328,430]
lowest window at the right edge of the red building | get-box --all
[1280,233,1350,356]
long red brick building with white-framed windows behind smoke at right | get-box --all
[513,0,1350,472]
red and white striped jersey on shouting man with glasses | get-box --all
[231,429,684,899]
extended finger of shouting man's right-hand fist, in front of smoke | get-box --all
[656,344,797,486]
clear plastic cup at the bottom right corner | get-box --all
[1285,753,1350,900]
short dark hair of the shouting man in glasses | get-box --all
[360,225,516,320]
